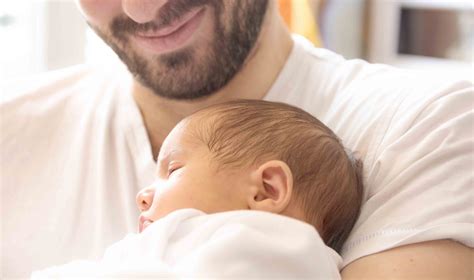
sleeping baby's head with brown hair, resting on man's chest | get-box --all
[137,100,363,251]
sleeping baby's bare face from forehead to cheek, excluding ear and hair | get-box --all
[137,122,250,232]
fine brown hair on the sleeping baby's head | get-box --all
[188,100,363,252]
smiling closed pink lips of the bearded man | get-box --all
[135,7,205,54]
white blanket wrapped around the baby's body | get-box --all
[32,209,341,279]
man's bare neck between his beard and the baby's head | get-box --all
[133,10,293,158]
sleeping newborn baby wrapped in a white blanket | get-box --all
[32,100,363,279]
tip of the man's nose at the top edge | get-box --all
[122,0,169,23]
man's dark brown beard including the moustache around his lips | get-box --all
[91,0,268,100]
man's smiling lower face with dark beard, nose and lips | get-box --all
[79,0,268,99]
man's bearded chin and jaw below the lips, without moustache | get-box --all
[94,0,268,100]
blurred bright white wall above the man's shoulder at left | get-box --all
[0,0,92,80]
